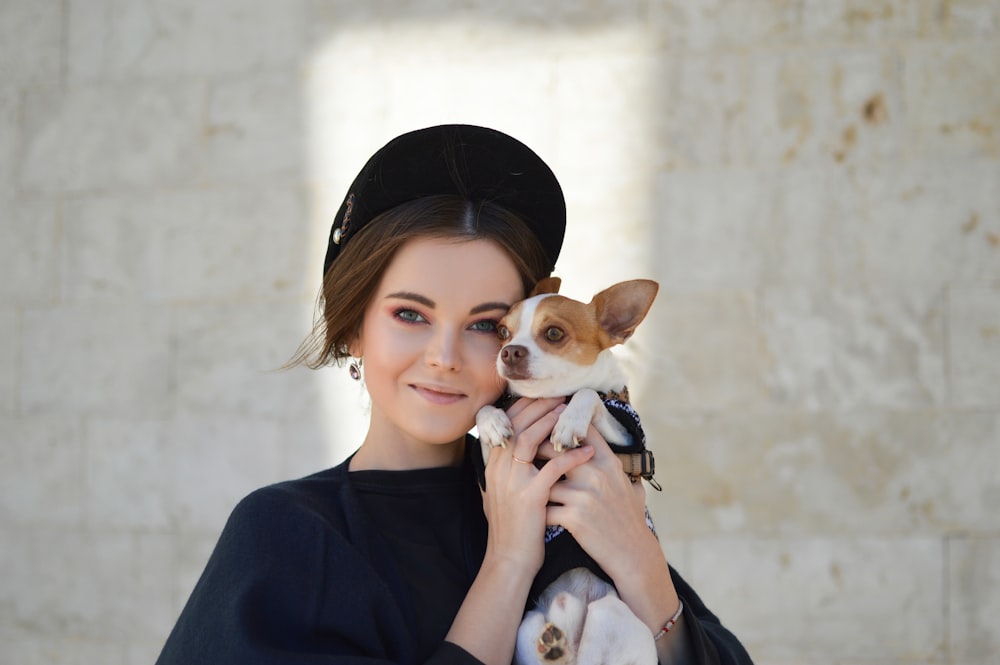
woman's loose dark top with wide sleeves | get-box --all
[157,439,750,665]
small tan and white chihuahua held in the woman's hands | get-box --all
[476,277,659,665]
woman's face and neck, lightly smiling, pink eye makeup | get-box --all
[353,238,524,468]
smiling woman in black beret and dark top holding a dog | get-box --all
[158,125,749,665]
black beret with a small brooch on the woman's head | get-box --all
[323,125,566,275]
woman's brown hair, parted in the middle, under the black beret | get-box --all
[288,195,549,369]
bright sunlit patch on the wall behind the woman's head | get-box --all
[305,19,658,461]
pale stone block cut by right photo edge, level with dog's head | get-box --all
[948,288,1000,411]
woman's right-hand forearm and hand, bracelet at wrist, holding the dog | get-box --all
[541,426,680,633]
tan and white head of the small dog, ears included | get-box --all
[497,277,659,397]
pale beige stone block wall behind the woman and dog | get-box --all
[0,0,1000,665]
